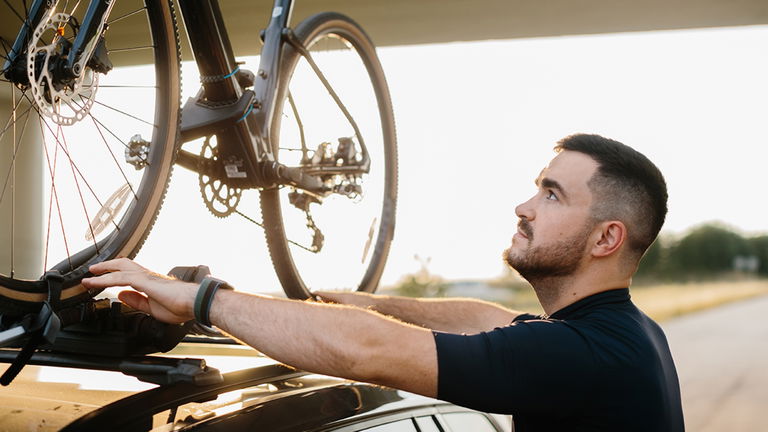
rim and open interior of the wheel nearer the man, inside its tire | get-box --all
[270,24,393,290]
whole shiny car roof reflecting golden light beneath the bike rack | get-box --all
[0,344,449,432]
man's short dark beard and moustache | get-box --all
[503,219,592,287]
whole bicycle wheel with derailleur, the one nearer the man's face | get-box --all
[261,13,397,298]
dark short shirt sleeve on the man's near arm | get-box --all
[434,320,599,415]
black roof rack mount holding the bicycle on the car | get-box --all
[0,266,237,385]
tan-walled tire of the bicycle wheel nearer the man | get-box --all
[260,12,397,299]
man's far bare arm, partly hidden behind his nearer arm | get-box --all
[316,291,520,334]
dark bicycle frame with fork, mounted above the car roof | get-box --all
[4,0,370,195]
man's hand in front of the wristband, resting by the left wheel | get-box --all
[83,258,198,324]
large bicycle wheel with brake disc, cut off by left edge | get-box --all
[0,0,180,315]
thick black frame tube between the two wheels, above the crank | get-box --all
[179,0,242,102]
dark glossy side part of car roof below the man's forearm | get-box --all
[62,364,445,431]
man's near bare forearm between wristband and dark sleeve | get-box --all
[210,291,437,396]
